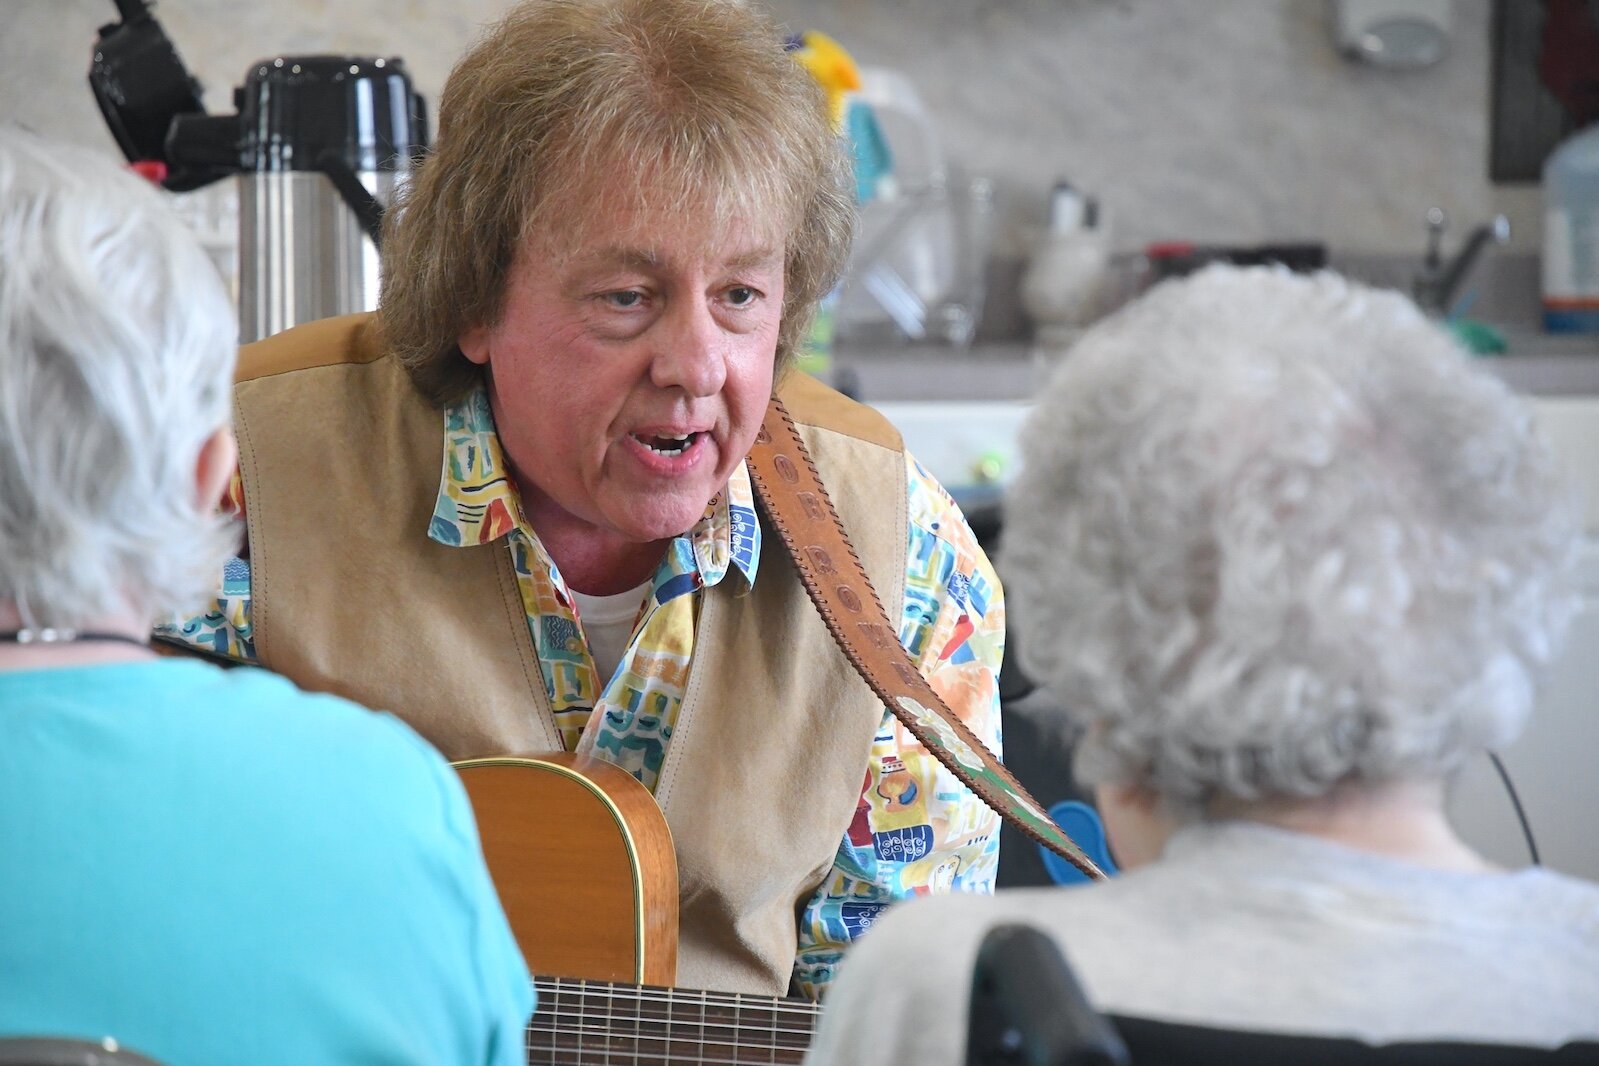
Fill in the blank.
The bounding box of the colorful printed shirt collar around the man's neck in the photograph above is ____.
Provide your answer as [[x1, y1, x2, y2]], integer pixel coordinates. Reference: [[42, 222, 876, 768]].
[[427, 385, 761, 598]]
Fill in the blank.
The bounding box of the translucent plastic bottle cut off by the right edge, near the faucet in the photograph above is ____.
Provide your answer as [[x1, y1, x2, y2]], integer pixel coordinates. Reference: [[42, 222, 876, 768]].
[[1543, 123, 1599, 332]]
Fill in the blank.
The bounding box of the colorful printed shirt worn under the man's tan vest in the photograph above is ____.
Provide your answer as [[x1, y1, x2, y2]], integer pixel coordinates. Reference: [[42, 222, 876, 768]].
[[165, 383, 1004, 999]]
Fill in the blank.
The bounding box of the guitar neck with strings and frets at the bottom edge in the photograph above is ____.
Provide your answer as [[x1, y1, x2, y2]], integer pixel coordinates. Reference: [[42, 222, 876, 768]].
[[528, 977, 822, 1066]]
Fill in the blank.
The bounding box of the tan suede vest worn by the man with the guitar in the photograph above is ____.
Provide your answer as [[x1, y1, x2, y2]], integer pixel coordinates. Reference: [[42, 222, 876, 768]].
[[235, 315, 908, 996]]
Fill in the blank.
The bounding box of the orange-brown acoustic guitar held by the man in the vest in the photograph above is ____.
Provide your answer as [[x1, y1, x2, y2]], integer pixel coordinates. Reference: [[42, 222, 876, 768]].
[[456, 753, 820, 1066]]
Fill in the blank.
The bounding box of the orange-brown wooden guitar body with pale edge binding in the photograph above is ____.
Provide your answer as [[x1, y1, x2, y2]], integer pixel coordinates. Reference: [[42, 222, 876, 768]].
[[454, 751, 678, 984]]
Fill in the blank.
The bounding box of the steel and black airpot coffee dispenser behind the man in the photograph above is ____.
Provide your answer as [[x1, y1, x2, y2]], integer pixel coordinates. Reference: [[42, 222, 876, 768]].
[[90, 0, 427, 340]]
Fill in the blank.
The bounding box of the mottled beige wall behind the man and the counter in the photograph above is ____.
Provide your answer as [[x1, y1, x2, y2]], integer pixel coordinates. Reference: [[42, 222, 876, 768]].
[[0, 0, 1538, 256]]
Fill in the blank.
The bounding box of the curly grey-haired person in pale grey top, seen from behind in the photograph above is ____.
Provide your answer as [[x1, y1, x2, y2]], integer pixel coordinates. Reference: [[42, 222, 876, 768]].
[[811, 267, 1599, 1063]]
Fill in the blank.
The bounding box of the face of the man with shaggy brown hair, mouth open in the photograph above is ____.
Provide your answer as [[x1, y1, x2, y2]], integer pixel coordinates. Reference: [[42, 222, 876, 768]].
[[461, 201, 784, 558]]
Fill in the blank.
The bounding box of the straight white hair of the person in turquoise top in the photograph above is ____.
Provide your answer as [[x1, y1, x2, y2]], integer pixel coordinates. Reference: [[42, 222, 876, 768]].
[[0, 126, 238, 628]]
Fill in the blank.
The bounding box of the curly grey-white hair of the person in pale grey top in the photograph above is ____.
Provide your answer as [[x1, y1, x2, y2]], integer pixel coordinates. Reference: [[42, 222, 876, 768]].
[[999, 267, 1580, 810]]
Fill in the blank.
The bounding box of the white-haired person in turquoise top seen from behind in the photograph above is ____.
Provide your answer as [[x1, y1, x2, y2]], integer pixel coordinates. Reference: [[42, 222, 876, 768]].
[[0, 128, 531, 1064]]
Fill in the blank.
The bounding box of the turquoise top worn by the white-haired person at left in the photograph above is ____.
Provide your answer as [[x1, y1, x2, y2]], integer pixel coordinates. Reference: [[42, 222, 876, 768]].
[[0, 660, 532, 1066]]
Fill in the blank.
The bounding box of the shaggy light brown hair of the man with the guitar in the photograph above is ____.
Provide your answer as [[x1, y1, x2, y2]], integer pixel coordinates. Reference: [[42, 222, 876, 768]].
[[379, 0, 854, 403]]
